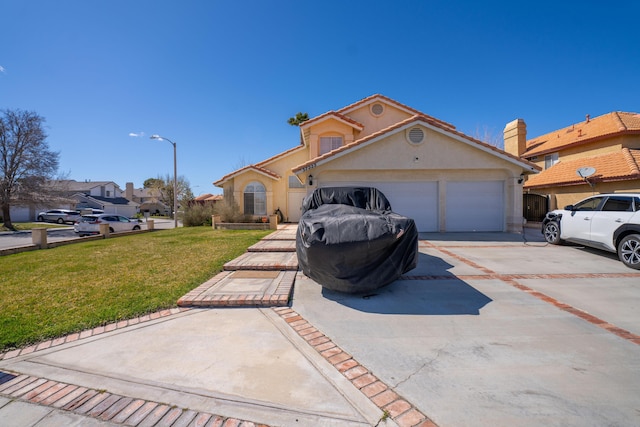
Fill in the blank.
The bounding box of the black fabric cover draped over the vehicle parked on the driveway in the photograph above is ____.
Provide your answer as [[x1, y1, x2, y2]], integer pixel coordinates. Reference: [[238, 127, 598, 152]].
[[296, 187, 418, 293]]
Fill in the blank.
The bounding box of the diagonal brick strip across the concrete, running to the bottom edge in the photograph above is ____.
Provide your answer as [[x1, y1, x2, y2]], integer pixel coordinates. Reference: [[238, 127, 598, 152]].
[[272, 307, 437, 427]]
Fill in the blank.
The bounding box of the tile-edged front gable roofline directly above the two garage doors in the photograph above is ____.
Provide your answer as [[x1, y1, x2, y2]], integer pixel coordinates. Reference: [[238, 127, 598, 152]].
[[292, 114, 540, 173]]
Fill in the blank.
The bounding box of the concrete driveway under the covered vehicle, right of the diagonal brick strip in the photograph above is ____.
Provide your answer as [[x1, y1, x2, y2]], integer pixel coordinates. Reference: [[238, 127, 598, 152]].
[[292, 229, 640, 427]]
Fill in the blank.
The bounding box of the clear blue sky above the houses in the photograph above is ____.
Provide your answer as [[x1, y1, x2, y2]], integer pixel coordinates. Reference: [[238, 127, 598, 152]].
[[0, 0, 640, 195]]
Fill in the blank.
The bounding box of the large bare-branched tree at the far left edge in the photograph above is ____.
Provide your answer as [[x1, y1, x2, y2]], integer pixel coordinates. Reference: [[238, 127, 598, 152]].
[[0, 110, 60, 230]]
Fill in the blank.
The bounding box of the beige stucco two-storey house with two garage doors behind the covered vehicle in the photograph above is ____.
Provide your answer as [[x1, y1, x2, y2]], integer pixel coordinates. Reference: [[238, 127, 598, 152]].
[[214, 95, 539, 232]]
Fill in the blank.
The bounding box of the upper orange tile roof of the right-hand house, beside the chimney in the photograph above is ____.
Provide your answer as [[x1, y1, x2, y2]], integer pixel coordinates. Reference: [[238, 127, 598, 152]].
[[522, 111, 640, 157]]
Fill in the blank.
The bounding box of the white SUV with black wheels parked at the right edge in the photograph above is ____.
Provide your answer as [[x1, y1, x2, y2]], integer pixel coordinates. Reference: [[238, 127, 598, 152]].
[[542, 193, 640, 270]]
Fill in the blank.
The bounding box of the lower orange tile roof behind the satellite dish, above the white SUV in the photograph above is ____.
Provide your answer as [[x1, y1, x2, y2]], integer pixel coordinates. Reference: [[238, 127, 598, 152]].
[[524, 148, 640, 189]]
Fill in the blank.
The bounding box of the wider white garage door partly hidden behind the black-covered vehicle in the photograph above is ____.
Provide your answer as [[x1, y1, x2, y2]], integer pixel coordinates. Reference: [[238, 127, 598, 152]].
[[321, 182, 438, 232]]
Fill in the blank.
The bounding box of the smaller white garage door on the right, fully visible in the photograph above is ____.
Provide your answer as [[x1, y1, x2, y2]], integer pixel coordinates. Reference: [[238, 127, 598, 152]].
[[445, 181, 504, 231]]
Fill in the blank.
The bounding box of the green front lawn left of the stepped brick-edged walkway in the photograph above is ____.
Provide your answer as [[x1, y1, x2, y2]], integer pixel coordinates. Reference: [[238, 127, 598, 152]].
[[0, 227, 270, 351]]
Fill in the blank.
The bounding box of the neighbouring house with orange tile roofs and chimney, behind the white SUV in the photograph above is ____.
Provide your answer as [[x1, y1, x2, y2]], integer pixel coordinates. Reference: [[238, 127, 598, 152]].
[[505, 112, 640, 216]]
